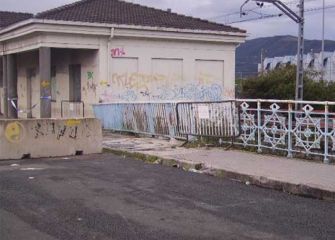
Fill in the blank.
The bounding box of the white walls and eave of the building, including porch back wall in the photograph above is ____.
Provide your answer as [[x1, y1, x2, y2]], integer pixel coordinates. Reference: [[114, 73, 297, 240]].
[[0, 28, 242, 118]]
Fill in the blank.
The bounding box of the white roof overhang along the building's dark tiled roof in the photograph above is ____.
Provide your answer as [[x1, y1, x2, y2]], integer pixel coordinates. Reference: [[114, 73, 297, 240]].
[[0, 19, 247, 44]]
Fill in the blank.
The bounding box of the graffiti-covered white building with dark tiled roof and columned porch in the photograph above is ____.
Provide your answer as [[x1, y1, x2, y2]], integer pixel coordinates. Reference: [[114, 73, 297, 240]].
[[0, 0, 246, 118]]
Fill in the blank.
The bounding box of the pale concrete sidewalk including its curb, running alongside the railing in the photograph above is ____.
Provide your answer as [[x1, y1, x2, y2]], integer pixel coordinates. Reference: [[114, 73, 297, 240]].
[[104, 134, 335, 200]]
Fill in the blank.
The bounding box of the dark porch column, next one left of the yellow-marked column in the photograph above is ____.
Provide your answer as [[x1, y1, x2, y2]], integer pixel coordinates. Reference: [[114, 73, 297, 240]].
[[6, 54, 17, 119]]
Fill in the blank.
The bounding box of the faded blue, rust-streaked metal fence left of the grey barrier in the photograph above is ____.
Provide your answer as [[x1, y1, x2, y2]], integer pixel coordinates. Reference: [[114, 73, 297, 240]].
[[93, 102, 185, 139]]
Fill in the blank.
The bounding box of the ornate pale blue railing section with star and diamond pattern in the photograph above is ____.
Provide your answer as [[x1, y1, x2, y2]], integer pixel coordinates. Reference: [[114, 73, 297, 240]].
[[235, 99, 335, 163]]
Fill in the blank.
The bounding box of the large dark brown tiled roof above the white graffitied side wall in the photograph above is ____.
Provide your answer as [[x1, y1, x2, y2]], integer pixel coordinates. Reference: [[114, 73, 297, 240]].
[[35, 0, 245, 33]]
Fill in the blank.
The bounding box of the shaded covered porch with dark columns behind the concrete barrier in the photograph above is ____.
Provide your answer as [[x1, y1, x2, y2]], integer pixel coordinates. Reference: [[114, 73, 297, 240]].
[[0, 47, 99, 119]]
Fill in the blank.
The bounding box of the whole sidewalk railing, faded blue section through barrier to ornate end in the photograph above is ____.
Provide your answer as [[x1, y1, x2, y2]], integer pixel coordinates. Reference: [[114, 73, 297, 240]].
[[94, 99, 335, 163]]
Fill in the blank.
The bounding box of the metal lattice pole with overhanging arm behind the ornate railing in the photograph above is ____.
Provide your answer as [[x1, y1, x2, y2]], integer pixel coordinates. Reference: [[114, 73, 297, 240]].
[[240, 0, 305, 104]]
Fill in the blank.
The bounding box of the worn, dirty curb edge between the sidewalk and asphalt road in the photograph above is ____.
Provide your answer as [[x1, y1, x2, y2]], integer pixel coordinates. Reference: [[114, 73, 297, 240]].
[[103, 147, 335, 201]]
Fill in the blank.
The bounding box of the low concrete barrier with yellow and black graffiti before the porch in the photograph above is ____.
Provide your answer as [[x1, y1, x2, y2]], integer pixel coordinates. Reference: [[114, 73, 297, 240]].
[[0, 118, 102, 159]]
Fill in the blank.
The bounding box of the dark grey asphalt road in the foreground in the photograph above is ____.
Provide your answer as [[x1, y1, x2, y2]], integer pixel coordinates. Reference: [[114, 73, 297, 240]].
[[0, 154, 335, 240]]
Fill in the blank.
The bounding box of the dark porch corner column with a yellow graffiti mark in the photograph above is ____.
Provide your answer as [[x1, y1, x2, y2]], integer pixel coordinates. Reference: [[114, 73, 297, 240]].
[[39, 47, 51, 118]]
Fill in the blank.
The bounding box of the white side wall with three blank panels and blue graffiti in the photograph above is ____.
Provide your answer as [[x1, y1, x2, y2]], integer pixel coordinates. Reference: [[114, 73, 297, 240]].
[[99, 39, 235, 102]]
